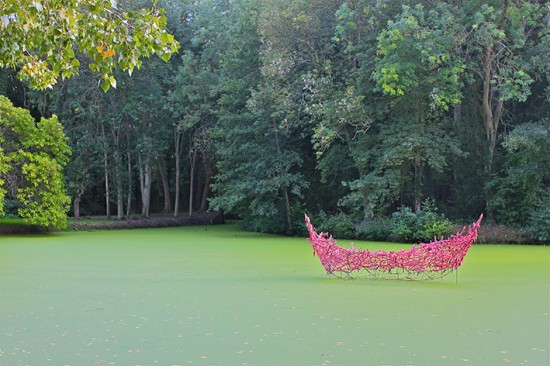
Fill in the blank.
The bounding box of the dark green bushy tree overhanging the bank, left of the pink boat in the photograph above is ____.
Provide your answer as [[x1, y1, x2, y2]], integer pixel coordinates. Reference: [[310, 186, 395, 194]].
[[210, 108, 307, 232]]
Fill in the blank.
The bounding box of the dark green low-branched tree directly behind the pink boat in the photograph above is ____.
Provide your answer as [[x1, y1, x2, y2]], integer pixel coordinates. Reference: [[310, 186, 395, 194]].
[[347, 114, 464, 213]]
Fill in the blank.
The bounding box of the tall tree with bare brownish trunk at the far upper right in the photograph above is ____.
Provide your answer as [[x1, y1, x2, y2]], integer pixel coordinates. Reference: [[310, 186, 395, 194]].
[[464, 0, 549, 173]]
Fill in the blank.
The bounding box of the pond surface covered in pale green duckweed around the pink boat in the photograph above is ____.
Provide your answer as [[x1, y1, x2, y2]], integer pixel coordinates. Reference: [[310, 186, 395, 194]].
[[0, 225, 550, 366]]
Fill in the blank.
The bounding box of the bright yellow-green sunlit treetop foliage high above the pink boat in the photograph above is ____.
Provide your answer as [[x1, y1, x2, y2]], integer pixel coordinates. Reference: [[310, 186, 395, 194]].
[[373, 3, 465, 110]]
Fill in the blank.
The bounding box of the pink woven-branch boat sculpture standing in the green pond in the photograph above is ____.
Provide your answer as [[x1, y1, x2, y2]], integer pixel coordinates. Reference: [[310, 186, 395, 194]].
[[305, 215, 483, 280]]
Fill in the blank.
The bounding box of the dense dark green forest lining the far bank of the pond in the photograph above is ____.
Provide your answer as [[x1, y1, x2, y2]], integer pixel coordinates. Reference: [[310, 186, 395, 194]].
[[0, 0, 550, 241]]
